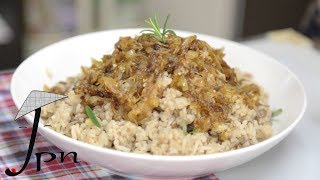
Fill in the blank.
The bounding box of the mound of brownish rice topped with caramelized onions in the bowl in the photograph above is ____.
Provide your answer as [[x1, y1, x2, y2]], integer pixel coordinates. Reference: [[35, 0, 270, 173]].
[[41, 35, 272, 155]]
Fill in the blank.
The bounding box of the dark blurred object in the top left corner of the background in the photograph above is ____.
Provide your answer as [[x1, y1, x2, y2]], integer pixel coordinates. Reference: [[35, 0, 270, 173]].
[[0, 0, 23, 70]]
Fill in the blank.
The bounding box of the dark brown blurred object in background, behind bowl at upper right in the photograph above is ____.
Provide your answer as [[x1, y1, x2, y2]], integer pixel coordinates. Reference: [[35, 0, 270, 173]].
[[243, 0, 311, 37]]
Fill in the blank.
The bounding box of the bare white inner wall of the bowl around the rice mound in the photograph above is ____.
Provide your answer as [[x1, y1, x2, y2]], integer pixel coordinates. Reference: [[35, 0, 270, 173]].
[[11, 29, 306, 139]]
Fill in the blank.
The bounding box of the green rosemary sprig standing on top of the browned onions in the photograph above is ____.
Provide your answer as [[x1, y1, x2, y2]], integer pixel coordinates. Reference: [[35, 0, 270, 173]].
[[140, 15, 176, 43]]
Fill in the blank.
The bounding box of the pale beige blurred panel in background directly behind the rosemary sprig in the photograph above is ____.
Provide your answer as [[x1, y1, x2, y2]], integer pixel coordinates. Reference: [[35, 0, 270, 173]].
[[99, 0, 245, 39]]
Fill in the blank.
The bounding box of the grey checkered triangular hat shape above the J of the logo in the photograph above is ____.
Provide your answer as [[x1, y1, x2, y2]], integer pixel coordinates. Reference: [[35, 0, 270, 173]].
[[14, 90, 67, 120]]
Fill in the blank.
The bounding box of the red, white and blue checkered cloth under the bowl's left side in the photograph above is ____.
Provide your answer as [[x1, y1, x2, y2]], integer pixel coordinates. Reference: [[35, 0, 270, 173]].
[[0, 73, 218, 180]]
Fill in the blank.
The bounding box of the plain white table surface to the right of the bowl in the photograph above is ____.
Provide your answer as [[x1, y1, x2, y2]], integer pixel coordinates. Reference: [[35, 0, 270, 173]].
[[217, 38, 320, 180]]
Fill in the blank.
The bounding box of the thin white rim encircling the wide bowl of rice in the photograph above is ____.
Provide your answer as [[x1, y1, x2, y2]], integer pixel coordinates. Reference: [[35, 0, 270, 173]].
[[10, 28, 307, 162]]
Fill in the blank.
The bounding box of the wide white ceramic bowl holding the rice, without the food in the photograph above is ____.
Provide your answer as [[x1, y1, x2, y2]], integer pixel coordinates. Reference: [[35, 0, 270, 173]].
[[11, 29, 306, 177]]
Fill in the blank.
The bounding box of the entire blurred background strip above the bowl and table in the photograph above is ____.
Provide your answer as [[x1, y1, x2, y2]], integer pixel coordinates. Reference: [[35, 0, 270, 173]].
[[0, 0, 320, 70]]
